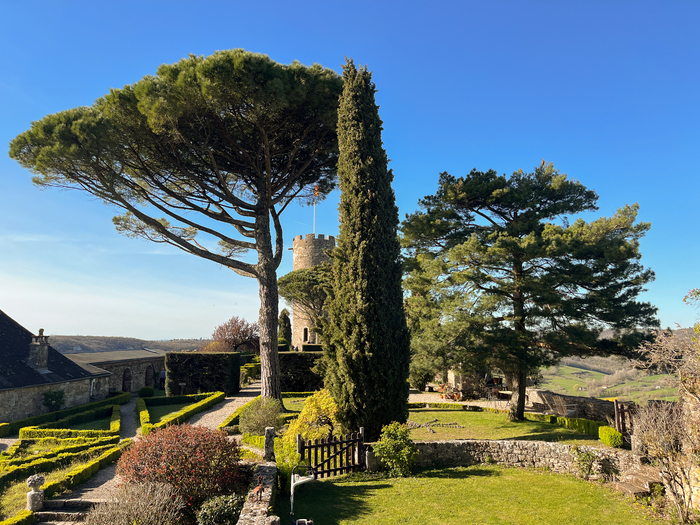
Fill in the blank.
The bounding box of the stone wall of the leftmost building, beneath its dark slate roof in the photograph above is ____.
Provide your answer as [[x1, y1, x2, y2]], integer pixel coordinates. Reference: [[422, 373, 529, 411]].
[[0, 377, 109, 423]]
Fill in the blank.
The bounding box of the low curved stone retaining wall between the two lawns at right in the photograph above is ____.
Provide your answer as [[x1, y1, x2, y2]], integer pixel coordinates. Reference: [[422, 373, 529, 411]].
[[368, 439, 639, 476]]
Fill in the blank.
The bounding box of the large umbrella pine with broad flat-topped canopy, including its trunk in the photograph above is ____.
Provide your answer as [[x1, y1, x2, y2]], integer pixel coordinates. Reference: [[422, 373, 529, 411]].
[[10, 49, 342, 397]]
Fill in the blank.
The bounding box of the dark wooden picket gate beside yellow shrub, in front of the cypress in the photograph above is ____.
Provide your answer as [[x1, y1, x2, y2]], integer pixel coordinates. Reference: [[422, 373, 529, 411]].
[[297, 428, 365, 478]]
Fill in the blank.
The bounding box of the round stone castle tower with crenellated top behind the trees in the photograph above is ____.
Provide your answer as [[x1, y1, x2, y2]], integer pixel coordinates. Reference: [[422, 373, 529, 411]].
[[292, 233, 335, 350]]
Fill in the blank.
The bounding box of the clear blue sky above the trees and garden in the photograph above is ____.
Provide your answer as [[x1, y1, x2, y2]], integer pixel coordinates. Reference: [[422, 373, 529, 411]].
[[0, 0, 700, 339]]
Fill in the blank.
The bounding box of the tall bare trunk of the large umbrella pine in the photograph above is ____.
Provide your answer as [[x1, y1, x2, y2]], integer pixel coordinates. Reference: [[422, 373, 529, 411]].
[[255, 211, 282, 400]]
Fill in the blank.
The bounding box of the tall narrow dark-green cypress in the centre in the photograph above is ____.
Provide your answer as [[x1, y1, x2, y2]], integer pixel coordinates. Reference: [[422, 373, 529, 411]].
[[322, 60, 409, 440]]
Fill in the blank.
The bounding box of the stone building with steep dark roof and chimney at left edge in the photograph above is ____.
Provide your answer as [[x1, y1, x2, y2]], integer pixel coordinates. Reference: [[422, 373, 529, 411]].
[[0, 310, 110, 423]]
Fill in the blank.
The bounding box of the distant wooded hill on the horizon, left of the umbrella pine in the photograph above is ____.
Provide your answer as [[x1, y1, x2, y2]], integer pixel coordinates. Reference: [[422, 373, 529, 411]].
[[49, 335, 211, 354]]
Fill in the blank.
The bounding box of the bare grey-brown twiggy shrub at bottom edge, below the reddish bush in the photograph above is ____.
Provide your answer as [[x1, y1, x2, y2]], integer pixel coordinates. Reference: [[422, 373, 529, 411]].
[[84, 483, 185, 525]]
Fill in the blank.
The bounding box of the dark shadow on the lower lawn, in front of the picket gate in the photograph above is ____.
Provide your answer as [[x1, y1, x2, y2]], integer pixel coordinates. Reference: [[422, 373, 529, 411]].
[[274, 480, 391, 525]]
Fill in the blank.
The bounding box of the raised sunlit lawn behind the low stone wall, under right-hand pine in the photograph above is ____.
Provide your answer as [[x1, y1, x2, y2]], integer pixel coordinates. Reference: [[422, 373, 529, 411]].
[[408, 408, 605, 446]]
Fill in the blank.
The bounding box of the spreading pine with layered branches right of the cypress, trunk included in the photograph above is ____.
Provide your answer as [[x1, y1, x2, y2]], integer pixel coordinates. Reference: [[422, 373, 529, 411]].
[[402, 161, 658, 419]]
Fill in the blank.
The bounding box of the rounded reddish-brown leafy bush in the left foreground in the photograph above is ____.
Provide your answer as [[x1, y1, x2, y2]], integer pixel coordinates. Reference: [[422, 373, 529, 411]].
[[117, 425, 248, 509]]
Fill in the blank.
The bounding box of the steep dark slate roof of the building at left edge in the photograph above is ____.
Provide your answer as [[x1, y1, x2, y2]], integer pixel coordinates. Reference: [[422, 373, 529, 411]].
[[0, 310, 102, 390]]
